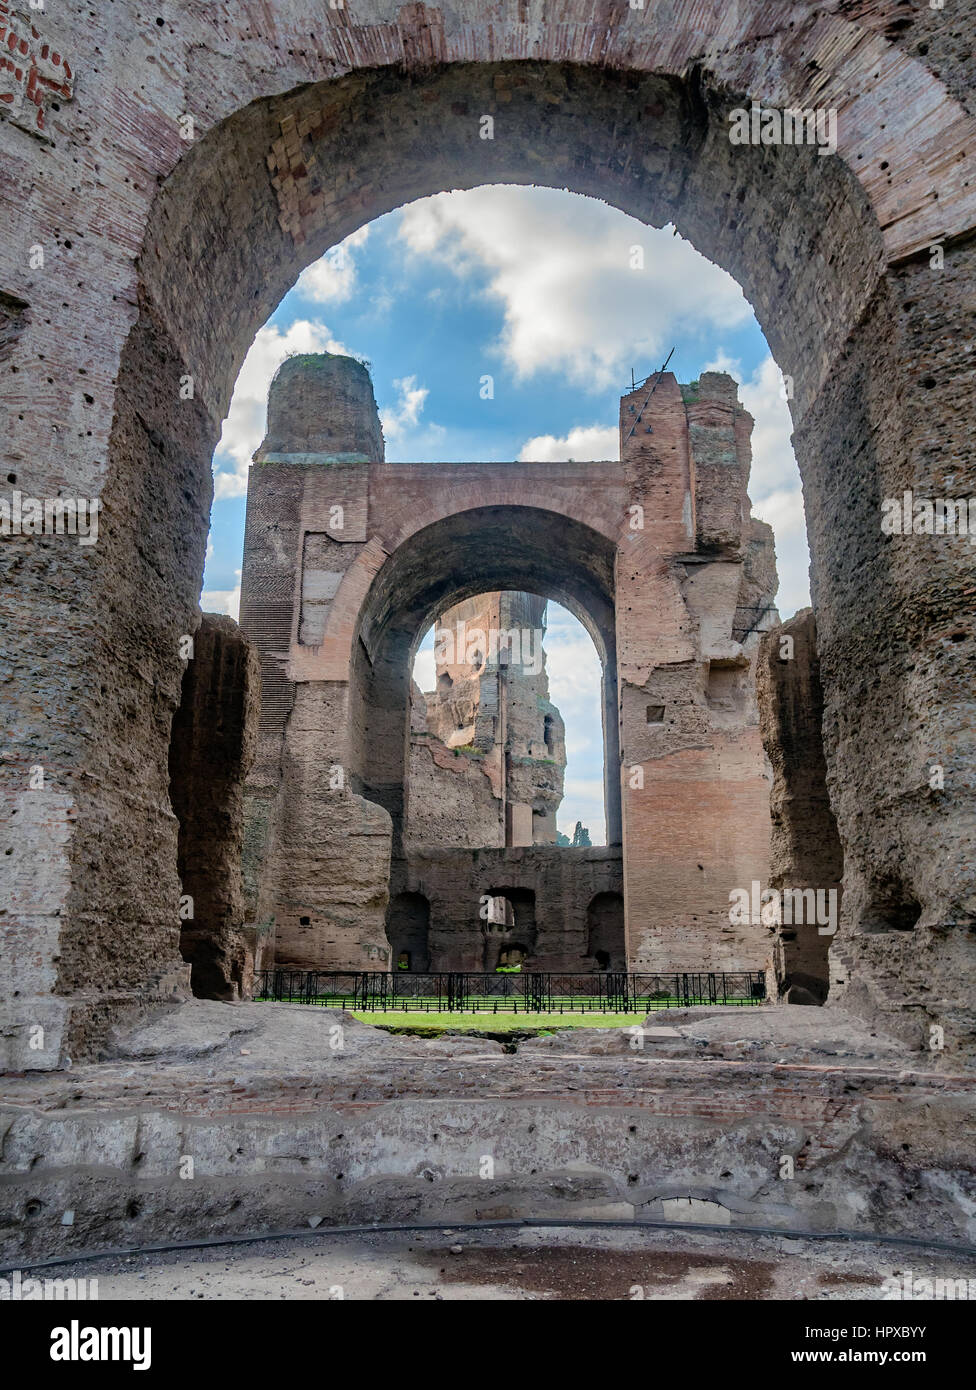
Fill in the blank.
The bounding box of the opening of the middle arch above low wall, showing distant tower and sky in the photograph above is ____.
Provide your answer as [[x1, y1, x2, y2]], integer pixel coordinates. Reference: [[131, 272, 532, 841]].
[[406, 592, 606, 849]]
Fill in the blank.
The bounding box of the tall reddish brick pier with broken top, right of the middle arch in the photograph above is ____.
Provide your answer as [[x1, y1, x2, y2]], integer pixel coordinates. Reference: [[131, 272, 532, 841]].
[[616, 373, 777, 970]]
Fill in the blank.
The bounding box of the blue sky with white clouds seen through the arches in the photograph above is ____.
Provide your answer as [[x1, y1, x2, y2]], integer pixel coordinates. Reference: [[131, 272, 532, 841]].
[[202, 186, 809, 844]]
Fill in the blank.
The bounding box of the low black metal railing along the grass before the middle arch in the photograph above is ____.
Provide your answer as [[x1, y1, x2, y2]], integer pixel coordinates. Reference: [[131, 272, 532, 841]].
[[254, 970, 766, 1015]]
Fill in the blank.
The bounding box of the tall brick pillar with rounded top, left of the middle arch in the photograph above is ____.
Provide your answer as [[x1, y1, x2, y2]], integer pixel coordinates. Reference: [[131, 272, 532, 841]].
[[241, 353, 392, 969]]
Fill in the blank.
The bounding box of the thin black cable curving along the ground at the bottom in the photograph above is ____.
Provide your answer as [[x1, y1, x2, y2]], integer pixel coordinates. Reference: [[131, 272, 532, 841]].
[[0, 1216, 976, 1275]]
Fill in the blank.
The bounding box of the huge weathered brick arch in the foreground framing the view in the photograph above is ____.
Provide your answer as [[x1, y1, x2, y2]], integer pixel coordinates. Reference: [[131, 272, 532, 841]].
[[0, 0, 976, 1055]]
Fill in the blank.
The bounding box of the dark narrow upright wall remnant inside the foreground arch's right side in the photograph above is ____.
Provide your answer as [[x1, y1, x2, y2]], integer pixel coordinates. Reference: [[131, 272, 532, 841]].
[[758, 609, 844, 1004]]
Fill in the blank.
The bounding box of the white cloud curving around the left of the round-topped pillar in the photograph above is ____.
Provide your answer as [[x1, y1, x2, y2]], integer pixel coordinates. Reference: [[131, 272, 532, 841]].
[[214, 318, 349, 498]]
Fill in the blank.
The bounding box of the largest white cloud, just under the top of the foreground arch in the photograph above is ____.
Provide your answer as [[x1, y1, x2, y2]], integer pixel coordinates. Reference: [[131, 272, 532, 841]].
[[399, 186, 751, 391]]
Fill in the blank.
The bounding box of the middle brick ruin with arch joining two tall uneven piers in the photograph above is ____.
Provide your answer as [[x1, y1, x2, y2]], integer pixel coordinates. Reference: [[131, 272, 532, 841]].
[[234, 354, 776, 970]]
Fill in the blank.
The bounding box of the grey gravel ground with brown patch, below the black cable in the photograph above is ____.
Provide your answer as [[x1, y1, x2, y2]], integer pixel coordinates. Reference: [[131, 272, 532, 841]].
[[17, 1227, 976, 1301]]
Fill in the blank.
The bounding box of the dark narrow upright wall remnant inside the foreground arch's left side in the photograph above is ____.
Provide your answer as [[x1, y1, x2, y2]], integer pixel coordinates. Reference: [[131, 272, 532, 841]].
[[170, 613, 261, 999]]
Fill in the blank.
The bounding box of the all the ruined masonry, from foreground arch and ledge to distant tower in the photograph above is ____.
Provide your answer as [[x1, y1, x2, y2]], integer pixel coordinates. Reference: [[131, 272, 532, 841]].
[[0, 0, 976, 1289]]
